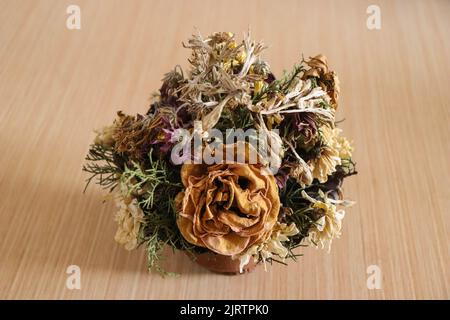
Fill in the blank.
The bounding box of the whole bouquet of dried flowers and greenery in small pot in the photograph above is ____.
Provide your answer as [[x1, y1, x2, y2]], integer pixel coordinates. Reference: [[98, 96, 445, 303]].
[[83, 32, 356, 274]]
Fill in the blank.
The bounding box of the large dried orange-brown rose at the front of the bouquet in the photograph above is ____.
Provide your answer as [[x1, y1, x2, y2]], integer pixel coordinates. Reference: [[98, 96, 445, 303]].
[[175, 144, 280, 256]]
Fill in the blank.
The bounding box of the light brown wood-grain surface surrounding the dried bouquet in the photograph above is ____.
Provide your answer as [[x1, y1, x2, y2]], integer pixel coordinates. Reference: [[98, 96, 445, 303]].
[[0, 0, 450, 299]]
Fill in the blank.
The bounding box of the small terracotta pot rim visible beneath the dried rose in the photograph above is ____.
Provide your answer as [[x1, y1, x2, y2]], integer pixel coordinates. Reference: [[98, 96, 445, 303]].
[[194, 252, 257, 275]]
